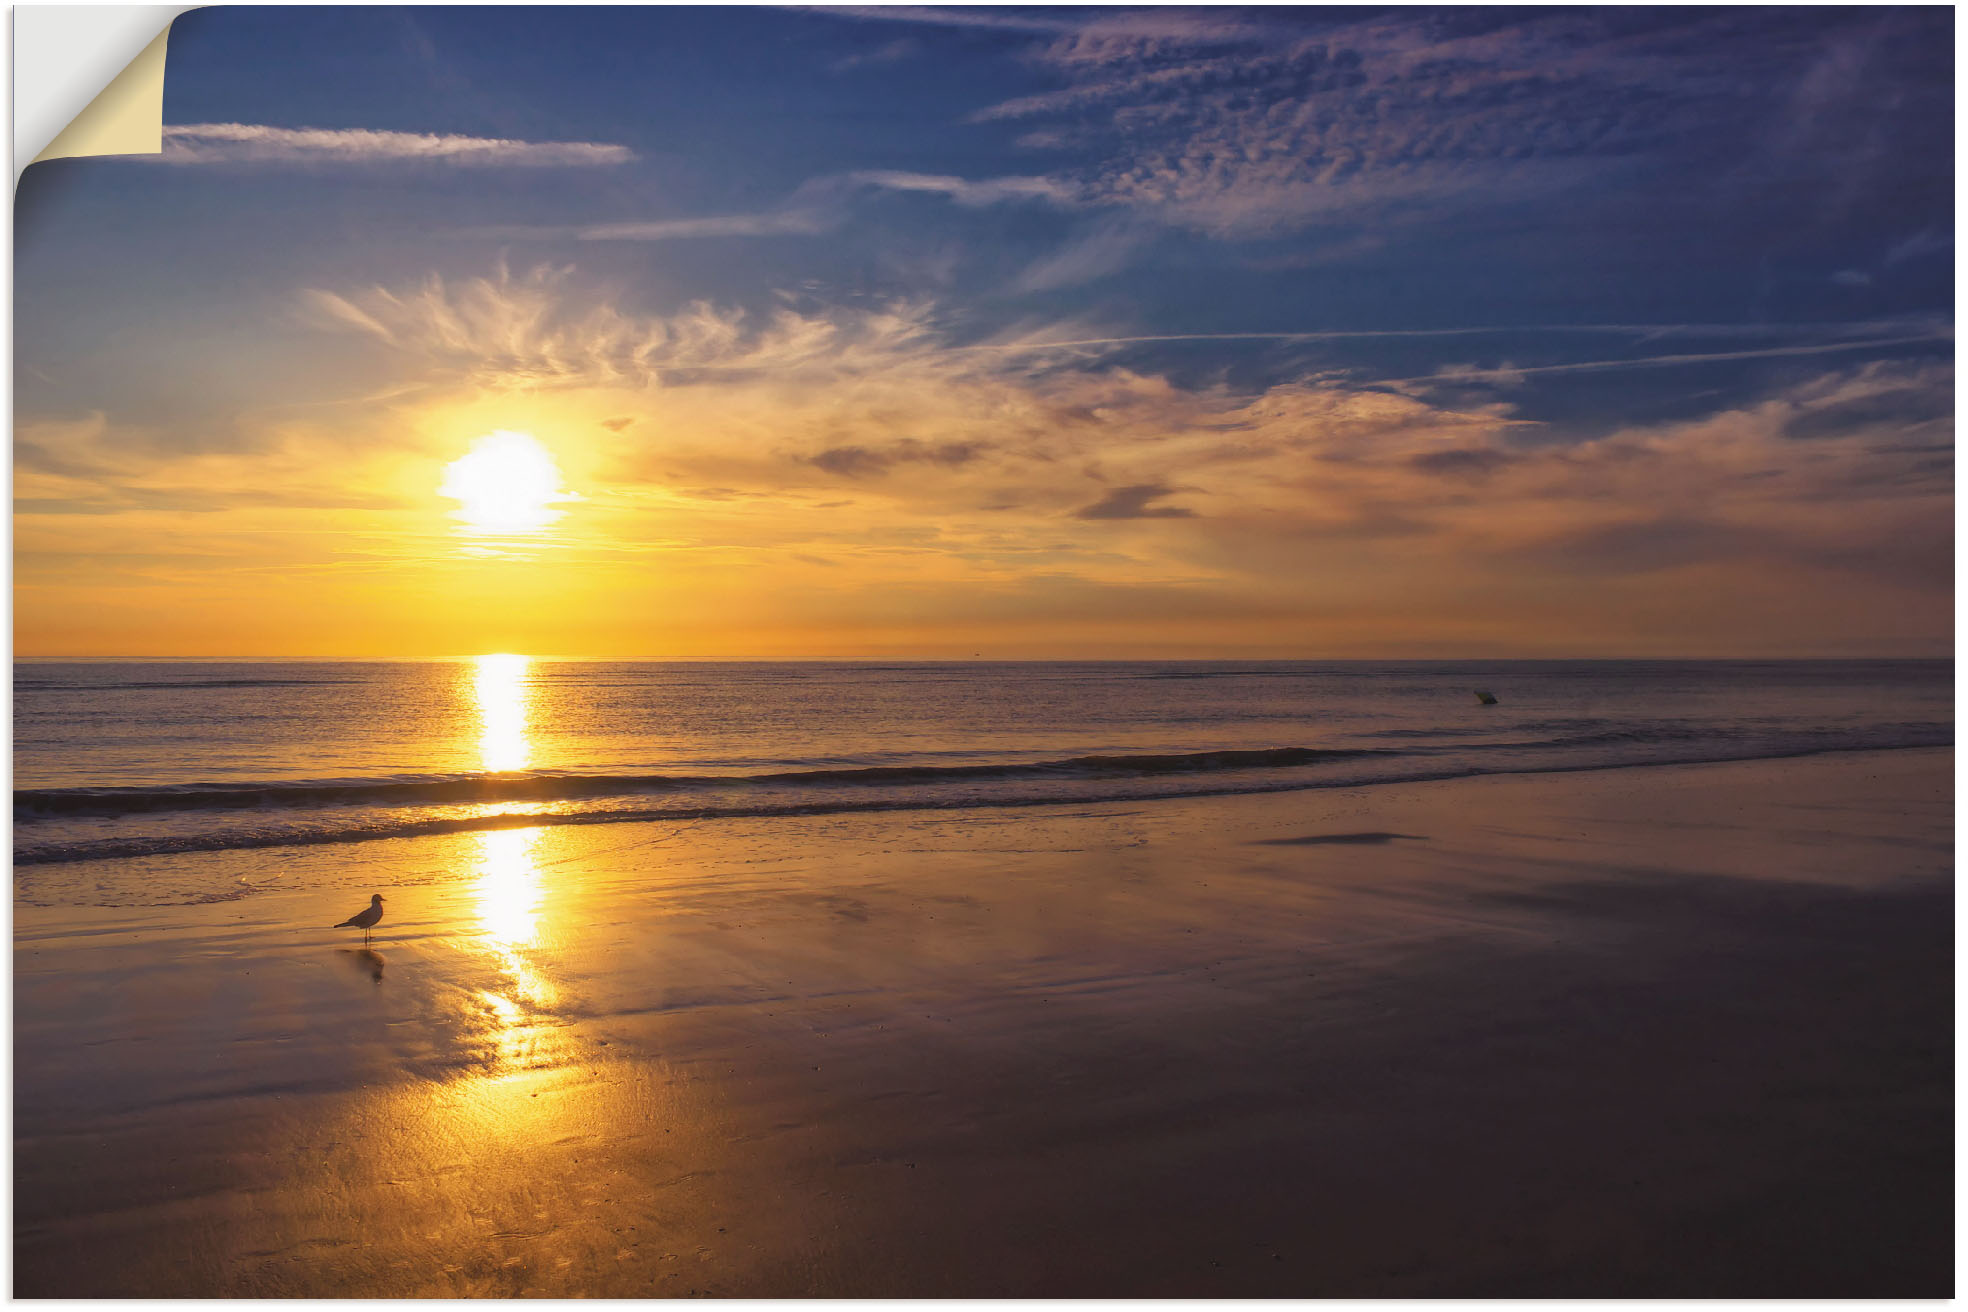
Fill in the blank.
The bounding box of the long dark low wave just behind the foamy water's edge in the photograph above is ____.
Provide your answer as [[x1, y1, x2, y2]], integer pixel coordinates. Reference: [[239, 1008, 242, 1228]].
[[14, 747, 1393, 822]]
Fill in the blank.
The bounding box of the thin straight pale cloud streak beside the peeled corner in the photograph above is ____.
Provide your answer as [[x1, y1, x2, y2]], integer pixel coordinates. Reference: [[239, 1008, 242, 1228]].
[[146, 124, 636, 167]]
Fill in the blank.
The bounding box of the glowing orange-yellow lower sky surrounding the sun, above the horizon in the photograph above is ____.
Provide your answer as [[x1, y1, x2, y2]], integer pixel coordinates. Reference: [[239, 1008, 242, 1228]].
[[16, 273, 1952, 659]]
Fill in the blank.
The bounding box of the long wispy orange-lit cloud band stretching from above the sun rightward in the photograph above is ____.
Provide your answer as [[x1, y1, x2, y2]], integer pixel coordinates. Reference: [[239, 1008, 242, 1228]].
[[295, 268, 1952, 541]]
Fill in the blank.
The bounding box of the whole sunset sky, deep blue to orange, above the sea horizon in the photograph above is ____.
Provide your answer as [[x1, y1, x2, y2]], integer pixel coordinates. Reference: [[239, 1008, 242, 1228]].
[[14, 6, 1954, 659]]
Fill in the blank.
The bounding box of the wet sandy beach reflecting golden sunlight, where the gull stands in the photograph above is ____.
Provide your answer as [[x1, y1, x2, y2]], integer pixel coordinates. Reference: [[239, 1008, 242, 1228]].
[[14, 749, 1952, 1298]]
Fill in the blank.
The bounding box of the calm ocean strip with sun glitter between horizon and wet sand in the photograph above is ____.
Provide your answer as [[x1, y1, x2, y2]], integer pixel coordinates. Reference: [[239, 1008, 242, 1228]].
[[14, 655, 1954, 905]]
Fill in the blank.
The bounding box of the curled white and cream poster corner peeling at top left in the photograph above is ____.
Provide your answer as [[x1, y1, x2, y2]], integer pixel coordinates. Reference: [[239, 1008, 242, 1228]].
[[14, 4, 195, 185]]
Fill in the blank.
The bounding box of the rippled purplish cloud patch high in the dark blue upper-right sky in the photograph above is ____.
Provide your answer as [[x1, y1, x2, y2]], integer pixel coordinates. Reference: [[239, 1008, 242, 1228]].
[[972, 18, 1668, 236]]
